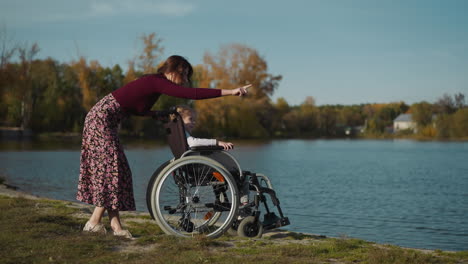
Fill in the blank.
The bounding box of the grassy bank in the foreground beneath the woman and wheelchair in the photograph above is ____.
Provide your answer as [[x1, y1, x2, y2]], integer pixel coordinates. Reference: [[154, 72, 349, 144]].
[[0, 196, 468, 264]]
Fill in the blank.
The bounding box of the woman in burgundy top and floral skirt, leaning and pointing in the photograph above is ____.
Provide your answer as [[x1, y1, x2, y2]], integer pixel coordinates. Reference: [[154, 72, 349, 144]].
[[77, 56, 250, 238]]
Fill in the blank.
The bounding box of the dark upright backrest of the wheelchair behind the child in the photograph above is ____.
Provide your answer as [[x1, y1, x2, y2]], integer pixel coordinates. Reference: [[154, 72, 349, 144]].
[[164, 114, 189, 159]]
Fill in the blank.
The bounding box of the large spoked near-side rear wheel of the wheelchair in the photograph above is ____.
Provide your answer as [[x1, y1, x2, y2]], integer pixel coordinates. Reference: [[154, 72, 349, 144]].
[[150, 156, 239, 238]]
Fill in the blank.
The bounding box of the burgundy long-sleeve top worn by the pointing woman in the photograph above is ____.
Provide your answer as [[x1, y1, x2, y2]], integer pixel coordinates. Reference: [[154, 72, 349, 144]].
[[112, 74, 221, 115]]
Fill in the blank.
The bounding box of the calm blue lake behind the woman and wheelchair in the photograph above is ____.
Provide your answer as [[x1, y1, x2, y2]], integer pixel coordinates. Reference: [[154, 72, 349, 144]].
[[0, 140, 468, 250]]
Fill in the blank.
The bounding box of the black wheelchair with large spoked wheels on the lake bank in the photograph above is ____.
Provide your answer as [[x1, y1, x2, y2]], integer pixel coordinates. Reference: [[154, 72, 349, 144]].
[[146, 110, 290, 238]]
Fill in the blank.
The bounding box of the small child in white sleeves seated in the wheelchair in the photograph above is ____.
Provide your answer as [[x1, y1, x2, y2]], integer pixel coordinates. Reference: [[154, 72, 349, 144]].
[[176, 105, 249, 207]]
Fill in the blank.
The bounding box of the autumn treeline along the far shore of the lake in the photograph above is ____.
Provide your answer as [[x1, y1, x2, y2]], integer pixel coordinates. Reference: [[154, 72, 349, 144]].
[[0, 33, 468, 138]]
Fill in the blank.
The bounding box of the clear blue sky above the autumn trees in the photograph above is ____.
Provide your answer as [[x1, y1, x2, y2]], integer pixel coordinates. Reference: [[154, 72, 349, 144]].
[[0, 0, 468, 105]]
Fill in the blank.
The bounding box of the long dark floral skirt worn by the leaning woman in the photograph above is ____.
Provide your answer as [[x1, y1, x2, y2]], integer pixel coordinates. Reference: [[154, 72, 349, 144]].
[[76, 94, 135, 211]]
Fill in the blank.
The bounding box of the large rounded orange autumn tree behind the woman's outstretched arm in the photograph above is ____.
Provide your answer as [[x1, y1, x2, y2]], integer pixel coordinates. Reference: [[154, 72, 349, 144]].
[[195, 44, 281, 137]]
